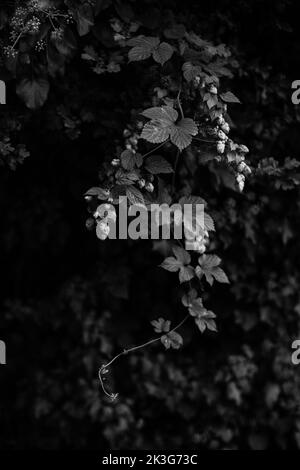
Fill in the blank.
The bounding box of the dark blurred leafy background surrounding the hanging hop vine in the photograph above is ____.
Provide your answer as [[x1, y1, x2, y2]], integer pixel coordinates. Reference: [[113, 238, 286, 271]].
[[0, 0, 300, 450]]
